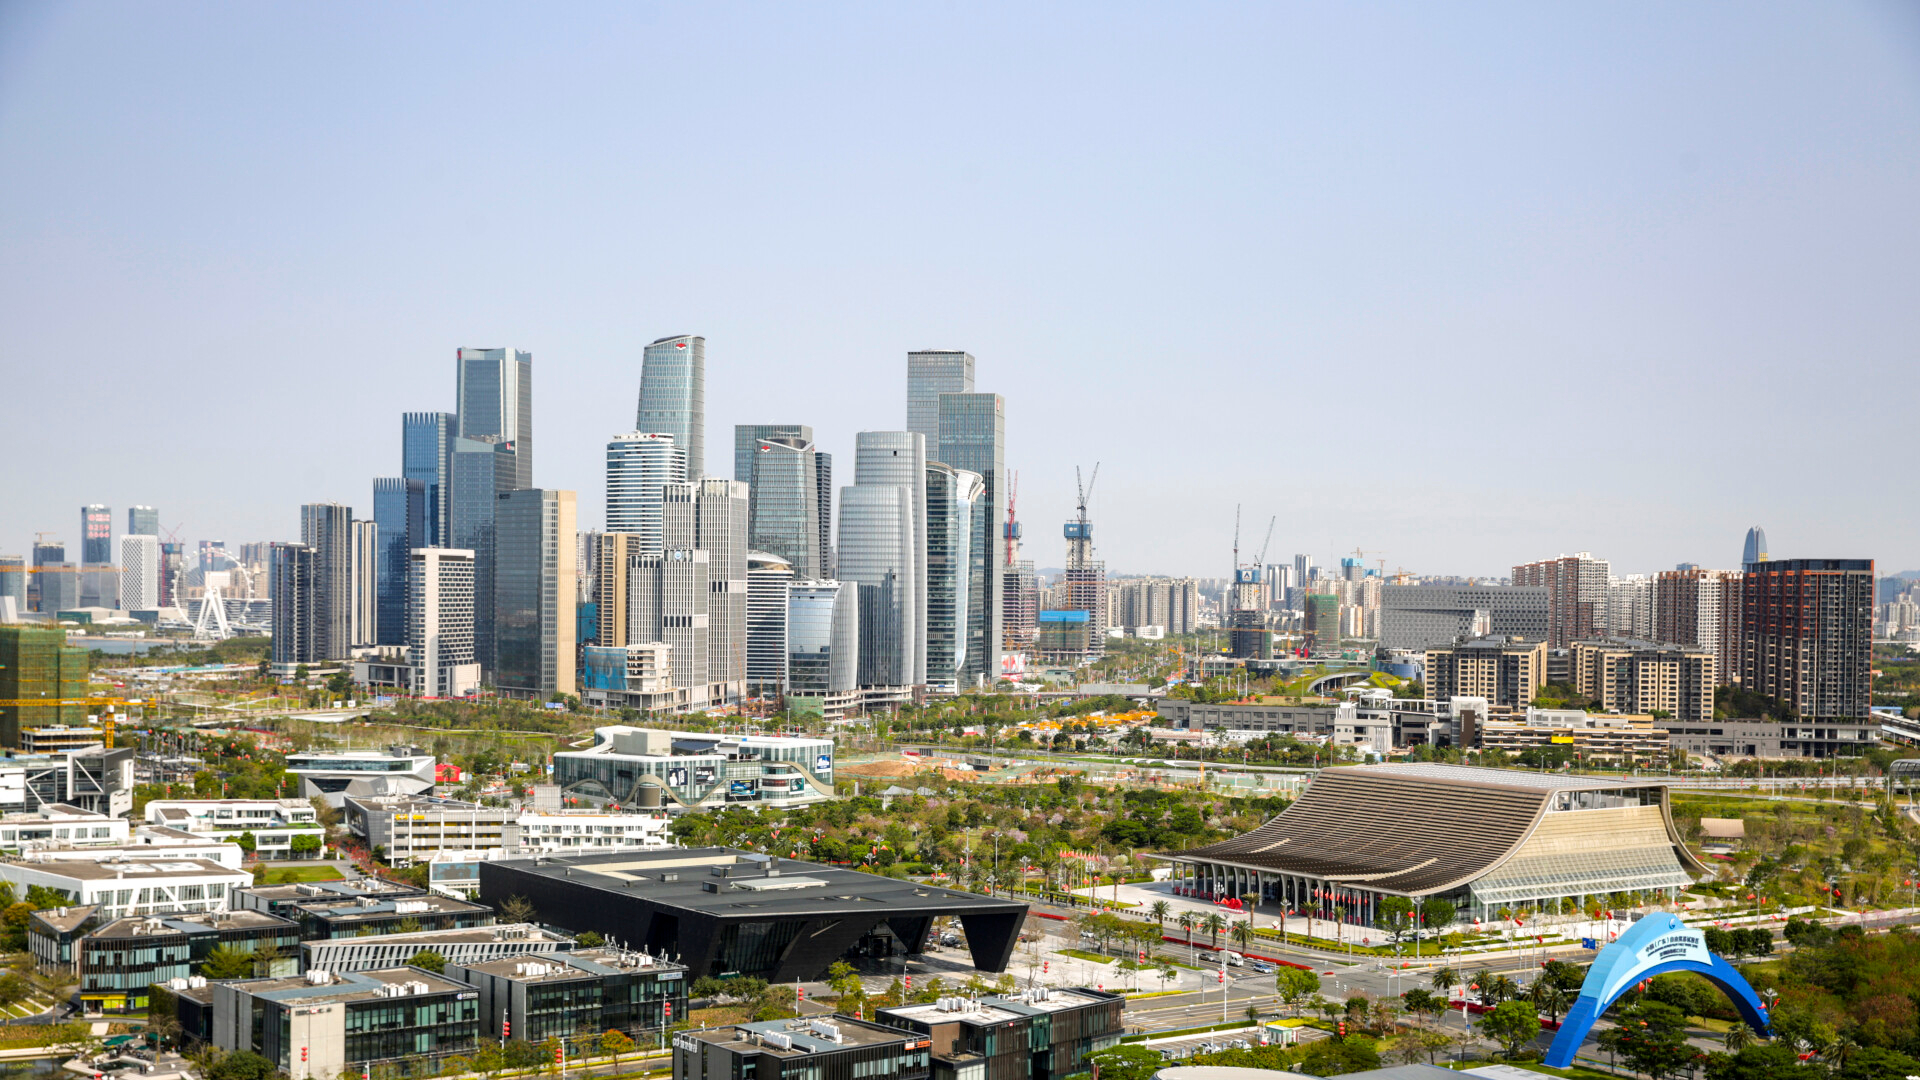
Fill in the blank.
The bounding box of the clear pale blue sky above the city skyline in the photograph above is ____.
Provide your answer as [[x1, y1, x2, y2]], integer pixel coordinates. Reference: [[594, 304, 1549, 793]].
[[0, 2, 1920, 575]]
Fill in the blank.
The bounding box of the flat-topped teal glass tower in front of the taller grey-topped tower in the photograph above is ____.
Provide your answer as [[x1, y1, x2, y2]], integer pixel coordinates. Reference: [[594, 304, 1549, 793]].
[[929, 393, 1006, 686]]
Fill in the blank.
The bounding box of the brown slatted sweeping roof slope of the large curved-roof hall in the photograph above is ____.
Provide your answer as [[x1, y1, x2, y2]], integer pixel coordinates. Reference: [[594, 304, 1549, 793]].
[[1173, 765, 1559, 896]]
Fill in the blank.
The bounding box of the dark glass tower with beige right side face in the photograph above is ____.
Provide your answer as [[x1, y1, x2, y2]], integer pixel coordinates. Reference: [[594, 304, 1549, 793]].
[[493, 488, 580, 701]]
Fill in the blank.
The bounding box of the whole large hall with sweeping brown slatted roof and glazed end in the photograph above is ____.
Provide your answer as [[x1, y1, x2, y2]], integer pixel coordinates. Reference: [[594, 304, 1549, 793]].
[[1164, 763, 1709, 924]]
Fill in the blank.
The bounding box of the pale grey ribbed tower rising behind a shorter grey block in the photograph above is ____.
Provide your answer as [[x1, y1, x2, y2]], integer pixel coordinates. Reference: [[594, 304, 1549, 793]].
[[660, 477, 747, 705]]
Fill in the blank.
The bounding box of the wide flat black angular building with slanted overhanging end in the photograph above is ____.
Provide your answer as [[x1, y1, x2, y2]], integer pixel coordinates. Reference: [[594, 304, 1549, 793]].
[[480, 847, 1027, 982]]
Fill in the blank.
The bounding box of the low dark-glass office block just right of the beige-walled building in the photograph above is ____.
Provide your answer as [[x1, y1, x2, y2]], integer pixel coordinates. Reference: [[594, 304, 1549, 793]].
[[447, 949, 687, 1042]]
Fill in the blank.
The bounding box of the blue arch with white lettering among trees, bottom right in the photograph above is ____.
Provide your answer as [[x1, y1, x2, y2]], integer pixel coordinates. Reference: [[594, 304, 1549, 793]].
[[1546, 915, 1768, 1068]]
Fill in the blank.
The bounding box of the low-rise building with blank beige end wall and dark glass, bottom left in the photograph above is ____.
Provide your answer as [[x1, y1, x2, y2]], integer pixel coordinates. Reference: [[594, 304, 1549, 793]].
[[206, 967, 480, 1080]]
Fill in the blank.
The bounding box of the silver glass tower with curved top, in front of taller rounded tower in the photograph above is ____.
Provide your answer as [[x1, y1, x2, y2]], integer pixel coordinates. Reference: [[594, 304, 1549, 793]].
[[839, 484, 925, 686]]
